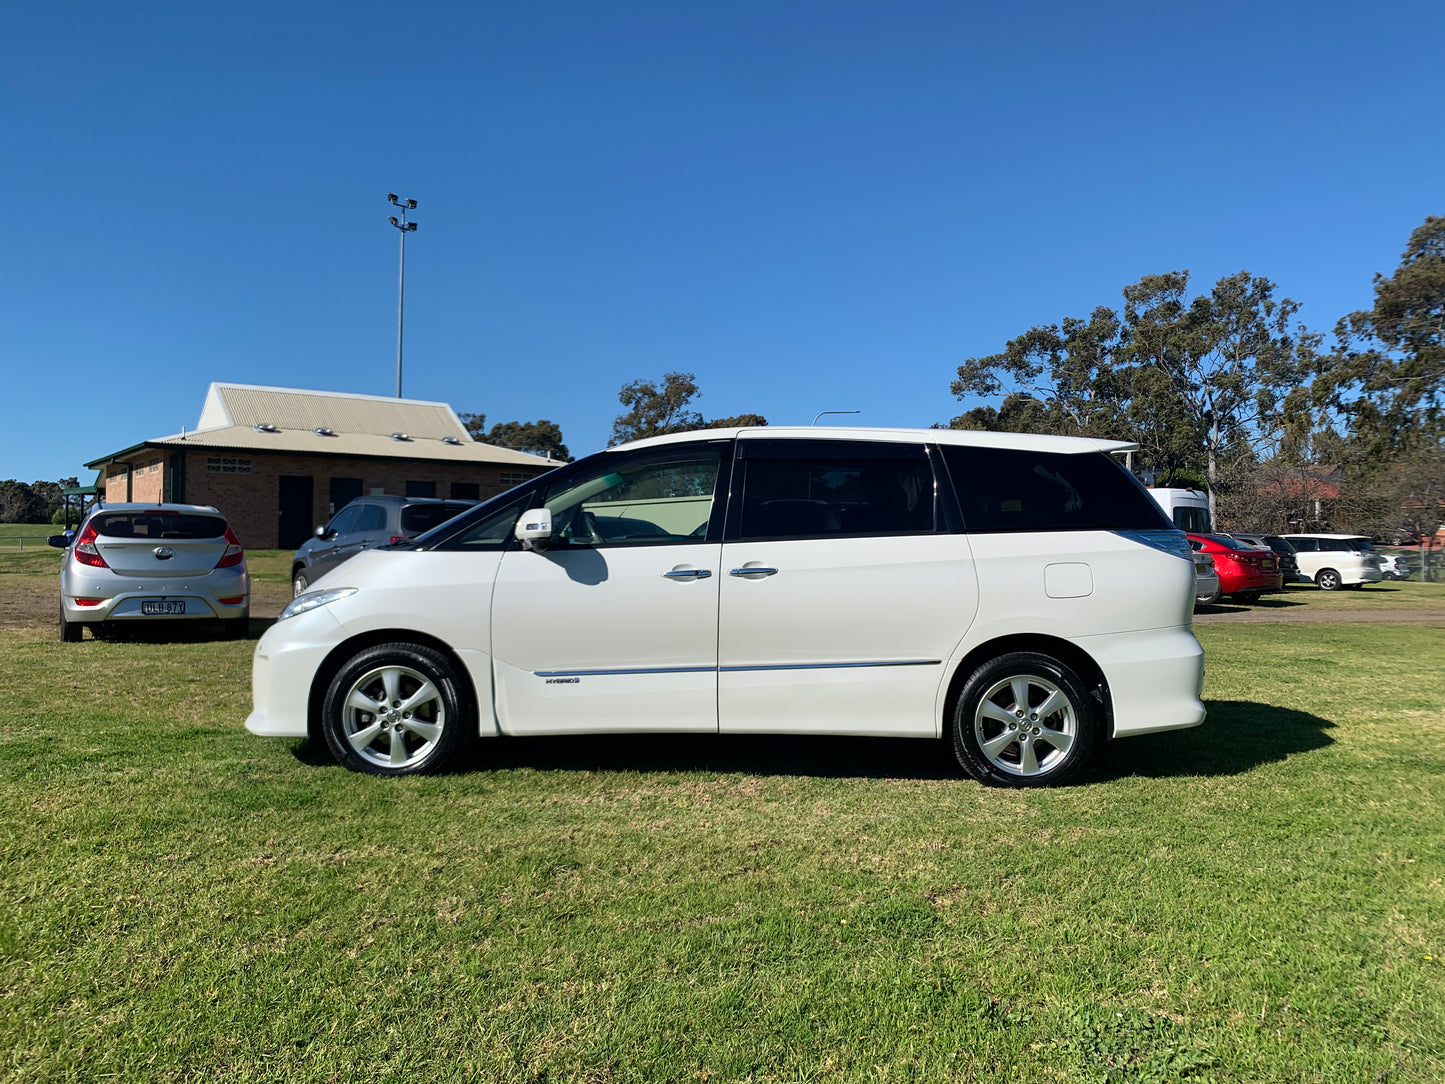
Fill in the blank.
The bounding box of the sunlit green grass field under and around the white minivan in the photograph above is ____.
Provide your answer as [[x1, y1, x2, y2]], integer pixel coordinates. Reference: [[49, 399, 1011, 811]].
[[0, 551, 1445, 1084]]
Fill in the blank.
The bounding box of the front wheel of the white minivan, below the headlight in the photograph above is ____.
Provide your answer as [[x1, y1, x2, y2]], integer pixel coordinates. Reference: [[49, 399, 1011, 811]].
[[321, 643, 475, 775]]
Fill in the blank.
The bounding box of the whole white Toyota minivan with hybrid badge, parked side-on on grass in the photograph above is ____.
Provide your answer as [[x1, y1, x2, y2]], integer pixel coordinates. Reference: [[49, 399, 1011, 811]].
[[246, 428, 1204, 786]]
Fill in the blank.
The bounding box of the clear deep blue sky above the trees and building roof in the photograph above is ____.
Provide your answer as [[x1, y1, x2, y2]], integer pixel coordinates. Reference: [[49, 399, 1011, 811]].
[[0, 0, 1445, 481]]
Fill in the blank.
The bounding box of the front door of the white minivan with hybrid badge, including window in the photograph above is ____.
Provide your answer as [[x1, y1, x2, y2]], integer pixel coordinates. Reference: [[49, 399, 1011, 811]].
[[491, 441, 728, 734]]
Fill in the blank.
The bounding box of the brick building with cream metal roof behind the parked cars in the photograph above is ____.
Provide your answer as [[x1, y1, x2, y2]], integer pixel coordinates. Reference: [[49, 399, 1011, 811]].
[[85, 383, 558, 549]]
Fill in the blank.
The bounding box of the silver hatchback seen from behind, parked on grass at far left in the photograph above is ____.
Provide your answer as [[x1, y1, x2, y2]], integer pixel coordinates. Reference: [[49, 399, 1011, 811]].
[[49, 503, 251, 643]]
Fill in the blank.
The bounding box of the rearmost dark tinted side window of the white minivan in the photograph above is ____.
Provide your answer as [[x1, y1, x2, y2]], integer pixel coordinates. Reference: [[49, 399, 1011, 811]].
[[942, 444, 1173, 533]]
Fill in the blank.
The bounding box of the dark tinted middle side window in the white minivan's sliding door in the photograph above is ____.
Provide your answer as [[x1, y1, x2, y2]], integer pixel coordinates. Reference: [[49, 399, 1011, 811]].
[[740, 458, 933, 539]]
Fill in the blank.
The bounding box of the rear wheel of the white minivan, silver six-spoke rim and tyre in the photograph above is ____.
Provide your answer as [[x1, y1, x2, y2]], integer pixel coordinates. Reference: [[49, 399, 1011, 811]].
[[952, 652, 1098, 788]]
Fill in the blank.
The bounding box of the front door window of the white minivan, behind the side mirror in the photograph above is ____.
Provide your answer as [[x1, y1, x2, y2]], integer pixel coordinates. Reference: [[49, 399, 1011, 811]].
[[543, 444, 725, 546]]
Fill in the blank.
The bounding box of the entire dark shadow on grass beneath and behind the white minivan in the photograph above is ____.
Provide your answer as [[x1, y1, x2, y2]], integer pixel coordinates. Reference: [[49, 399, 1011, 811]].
[[290, 700, 1334, 786]]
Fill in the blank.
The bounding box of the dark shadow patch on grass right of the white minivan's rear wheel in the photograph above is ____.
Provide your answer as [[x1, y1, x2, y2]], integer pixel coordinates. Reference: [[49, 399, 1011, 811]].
[[1079, 700, 1335, 783]]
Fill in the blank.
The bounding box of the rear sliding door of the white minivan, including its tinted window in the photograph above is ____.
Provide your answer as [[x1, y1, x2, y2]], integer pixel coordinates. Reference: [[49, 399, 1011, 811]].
[[718, 439, 978, 737]]
